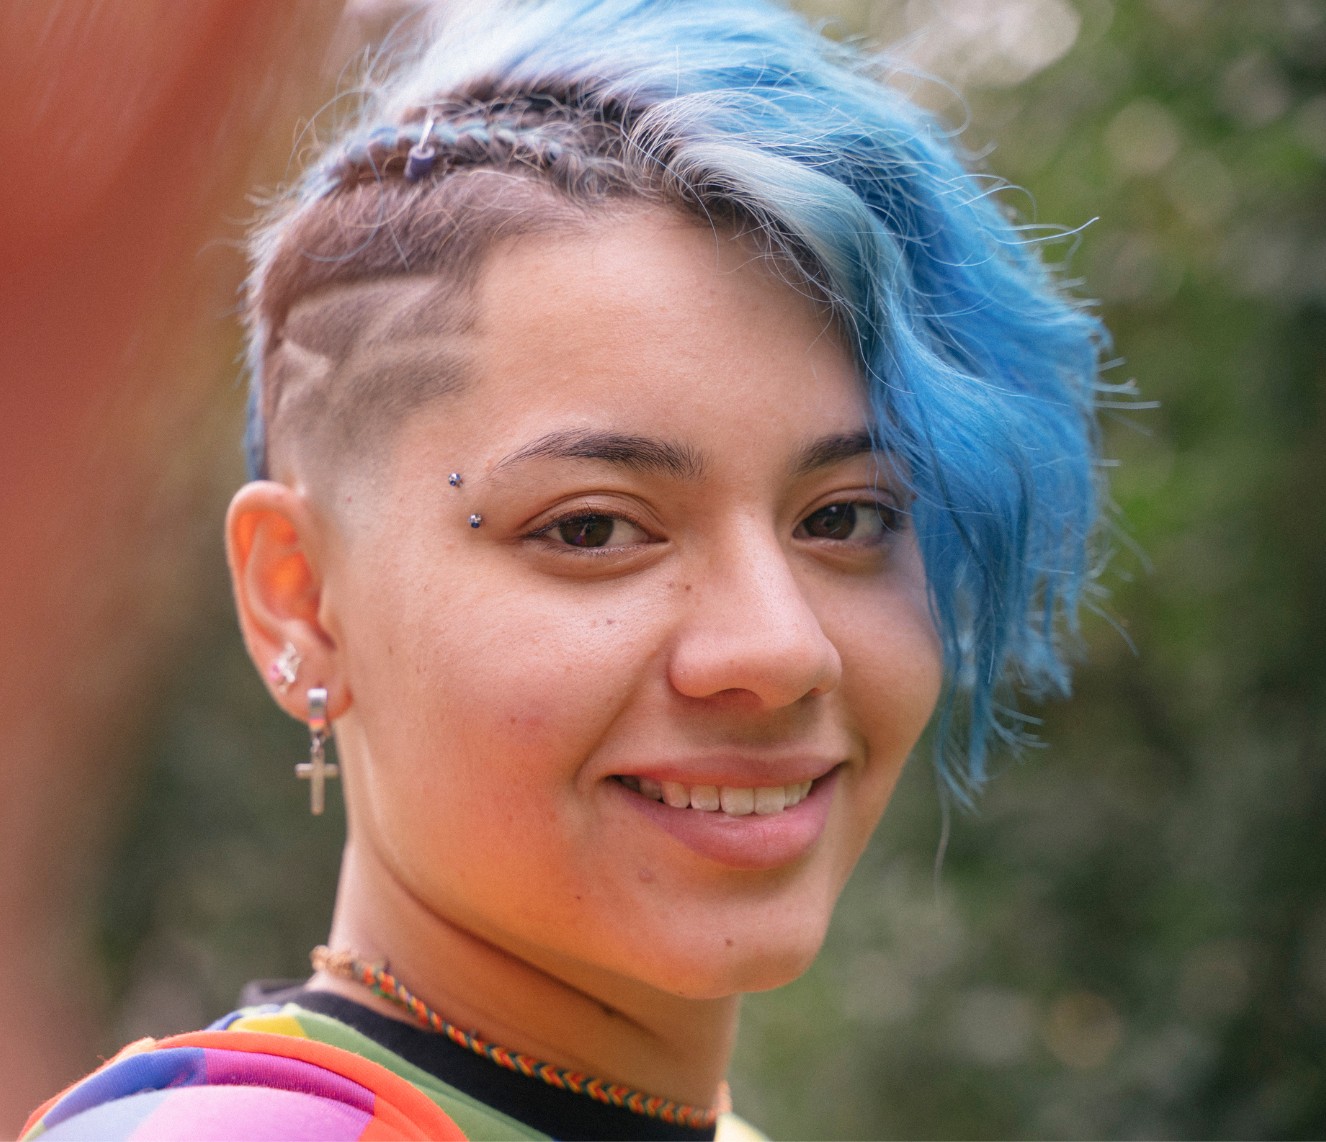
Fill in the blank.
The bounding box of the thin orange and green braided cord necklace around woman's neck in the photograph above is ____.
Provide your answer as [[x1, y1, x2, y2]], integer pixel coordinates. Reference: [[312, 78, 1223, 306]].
[[309, 946, 729, 1130]]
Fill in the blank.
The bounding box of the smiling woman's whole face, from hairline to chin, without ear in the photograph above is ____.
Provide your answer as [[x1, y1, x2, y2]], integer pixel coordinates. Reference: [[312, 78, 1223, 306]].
[[322, 210, 940, 996]]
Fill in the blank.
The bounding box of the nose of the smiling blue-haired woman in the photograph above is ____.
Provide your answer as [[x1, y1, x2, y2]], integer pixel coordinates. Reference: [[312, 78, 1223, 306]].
[[668, 525, 842, 710]]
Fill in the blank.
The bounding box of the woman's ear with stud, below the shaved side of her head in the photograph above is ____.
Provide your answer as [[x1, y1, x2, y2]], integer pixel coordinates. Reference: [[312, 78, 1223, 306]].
[[225, 480, 351, 722]]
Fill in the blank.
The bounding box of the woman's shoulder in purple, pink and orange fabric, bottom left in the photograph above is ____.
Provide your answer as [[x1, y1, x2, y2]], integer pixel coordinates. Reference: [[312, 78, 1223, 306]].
[[23, 1009, 467, 1142]]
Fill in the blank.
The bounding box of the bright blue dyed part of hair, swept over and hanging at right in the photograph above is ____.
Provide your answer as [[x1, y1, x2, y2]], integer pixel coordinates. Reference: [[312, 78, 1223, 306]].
[[249, 0, 1107, 801]]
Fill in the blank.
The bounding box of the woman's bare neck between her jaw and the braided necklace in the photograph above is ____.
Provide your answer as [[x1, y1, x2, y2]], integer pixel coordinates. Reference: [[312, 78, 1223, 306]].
[[313, 842, 739, 1106]]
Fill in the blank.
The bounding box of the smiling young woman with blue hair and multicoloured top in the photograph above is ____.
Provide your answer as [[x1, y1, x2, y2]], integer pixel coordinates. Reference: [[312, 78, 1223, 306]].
[[29, 0, 1101, 1138]]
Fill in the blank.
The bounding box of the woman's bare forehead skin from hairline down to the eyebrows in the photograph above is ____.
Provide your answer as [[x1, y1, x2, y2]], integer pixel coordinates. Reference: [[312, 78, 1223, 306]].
[[350, 211, 869, 495]]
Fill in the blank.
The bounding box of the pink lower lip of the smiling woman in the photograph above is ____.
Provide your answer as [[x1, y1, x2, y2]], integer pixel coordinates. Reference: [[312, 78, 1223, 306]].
[[607, 769, 838, 871]]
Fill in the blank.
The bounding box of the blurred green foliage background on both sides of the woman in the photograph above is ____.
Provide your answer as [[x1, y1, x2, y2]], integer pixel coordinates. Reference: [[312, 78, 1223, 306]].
[[98, 0, 1326, 1138]]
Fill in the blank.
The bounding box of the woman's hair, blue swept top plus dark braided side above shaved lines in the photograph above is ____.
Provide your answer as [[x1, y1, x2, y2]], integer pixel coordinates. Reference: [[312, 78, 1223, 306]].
[[248, 0, 1106, 800]]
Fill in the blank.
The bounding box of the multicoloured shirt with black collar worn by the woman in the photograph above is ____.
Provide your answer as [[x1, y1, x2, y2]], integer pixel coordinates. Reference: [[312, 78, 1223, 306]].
[[21, 992, 761, 1142]]
